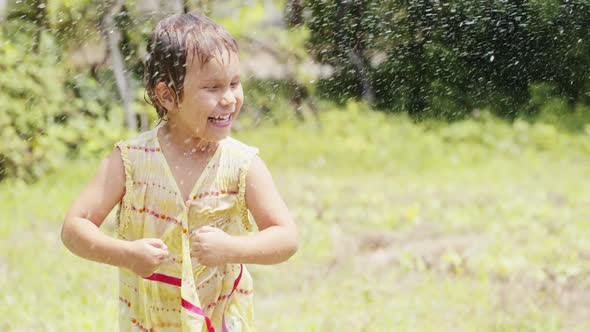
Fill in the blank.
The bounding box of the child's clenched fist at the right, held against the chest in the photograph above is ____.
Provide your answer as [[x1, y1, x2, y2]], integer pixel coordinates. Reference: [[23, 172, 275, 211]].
[[191, 226, 234, 266]]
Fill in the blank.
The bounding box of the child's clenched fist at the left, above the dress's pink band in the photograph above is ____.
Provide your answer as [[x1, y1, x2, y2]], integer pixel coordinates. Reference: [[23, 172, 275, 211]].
[[128, 239, 169, 277]]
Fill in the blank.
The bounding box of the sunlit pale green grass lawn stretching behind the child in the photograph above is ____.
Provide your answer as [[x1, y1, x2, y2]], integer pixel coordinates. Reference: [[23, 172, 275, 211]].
[[0, 104, 590, 332]]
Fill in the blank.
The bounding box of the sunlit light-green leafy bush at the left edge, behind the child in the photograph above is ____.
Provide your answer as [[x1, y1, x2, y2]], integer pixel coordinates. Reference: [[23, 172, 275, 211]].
[[0, 41, 129, 181]]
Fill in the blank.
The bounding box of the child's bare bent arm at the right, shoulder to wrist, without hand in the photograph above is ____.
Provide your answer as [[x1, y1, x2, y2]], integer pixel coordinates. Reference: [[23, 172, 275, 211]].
[[229, 157, 298, 264]]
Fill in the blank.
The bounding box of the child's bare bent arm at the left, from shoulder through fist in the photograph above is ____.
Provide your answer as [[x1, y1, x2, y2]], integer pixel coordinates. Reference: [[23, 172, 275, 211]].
[[61, 149, 168, 275]]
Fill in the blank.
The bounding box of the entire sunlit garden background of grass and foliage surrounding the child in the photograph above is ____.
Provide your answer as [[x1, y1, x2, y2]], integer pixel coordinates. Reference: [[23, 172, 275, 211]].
[[0, 0, 590, 332]]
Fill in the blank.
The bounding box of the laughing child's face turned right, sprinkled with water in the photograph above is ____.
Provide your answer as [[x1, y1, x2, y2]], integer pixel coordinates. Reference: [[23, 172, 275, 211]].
[[170, 52, 244, 142]]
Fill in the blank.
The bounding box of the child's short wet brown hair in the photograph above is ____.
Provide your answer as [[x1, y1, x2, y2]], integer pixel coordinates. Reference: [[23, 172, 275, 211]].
[[143, 13, 239, 119]]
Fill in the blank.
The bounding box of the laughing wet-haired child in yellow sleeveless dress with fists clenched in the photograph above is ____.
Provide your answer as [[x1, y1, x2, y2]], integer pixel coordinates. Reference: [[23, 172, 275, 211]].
[[62, 14, 297, 332]]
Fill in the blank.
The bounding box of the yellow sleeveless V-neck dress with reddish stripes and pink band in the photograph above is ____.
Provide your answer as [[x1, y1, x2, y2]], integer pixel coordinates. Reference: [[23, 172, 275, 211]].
[[116, 126, 258, 332]]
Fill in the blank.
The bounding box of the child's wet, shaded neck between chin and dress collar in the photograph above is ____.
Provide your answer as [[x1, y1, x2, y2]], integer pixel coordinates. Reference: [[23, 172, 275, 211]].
[[159, 122, 218, 157]]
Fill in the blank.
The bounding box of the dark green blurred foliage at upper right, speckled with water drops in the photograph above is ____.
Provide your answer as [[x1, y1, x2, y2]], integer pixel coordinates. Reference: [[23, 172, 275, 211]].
[[305, 0, 590, 119]]
